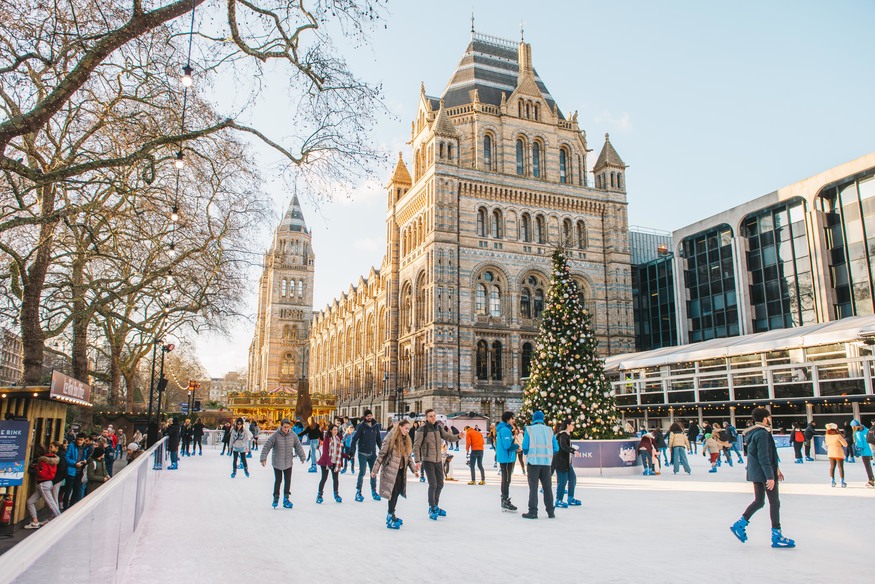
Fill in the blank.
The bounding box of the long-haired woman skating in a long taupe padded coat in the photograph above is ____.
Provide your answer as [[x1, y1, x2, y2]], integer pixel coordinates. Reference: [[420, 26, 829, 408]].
[[371, 418, 419, 529]]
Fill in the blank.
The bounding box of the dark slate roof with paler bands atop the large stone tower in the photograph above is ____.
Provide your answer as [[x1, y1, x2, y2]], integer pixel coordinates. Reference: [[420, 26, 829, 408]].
[[441, 33, 565, 119]]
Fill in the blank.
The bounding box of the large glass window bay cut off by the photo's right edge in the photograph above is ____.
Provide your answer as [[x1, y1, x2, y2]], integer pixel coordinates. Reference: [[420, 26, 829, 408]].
[[817, 171, 875, 318]]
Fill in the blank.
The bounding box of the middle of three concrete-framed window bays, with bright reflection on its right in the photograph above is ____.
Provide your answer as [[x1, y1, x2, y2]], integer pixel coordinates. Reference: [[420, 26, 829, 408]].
[[742, 198, 817, 333]]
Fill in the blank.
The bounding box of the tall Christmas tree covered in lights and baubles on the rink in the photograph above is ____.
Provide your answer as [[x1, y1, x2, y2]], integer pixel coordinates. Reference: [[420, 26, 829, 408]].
[[520, 248, 618, 438]]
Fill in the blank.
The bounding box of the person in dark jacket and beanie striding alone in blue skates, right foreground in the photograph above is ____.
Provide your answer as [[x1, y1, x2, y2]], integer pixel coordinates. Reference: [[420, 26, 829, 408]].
[[729, 408, 796, 548]]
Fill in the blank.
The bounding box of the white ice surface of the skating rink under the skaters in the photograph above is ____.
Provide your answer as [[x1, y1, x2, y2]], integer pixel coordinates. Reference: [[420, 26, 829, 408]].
[[121, 449, 875, 584]]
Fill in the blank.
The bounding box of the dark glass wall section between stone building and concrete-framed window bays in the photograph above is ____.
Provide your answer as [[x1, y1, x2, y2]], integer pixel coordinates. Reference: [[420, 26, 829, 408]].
[[632, 254, 678, 351]]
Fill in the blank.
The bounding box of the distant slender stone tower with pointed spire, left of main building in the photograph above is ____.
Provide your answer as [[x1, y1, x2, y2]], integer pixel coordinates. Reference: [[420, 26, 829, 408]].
[[247, 196, 315, 392]]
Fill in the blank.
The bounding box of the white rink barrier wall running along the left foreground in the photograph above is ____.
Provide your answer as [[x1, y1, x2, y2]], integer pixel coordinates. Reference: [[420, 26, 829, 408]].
[[0, 438, 166, 584]]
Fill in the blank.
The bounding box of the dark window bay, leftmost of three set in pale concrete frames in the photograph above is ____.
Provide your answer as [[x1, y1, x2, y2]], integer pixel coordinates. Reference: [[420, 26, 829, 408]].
[[681, 223, 739, 343]]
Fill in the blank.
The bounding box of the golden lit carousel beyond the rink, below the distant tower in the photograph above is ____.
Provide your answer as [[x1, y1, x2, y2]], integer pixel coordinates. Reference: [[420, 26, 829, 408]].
[[227, 382, 336, 429]]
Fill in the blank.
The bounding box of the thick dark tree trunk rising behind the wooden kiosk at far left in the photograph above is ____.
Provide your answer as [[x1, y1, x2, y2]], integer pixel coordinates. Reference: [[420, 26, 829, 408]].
[[21, 186, 58, 385]]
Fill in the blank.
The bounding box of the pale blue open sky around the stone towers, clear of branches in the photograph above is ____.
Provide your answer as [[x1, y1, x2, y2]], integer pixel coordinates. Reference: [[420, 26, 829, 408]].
[[193, 0, 875, 377]]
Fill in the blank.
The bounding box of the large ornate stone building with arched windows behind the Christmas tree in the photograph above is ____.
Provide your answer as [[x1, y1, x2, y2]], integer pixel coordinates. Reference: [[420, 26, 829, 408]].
[[310, 34, 634, 421]]
